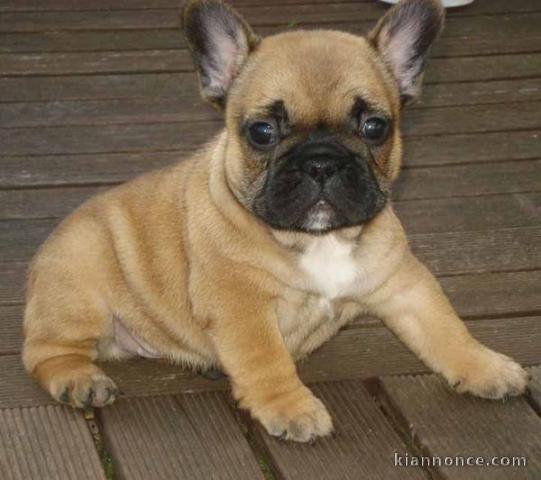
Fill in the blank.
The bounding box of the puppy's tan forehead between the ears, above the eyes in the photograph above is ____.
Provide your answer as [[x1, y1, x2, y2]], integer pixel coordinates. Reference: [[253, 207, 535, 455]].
[[229, 31, 398, 125]]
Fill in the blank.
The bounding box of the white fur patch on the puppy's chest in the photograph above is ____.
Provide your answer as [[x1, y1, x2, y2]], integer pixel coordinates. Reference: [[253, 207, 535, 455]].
[[300, 235, 359, 299]]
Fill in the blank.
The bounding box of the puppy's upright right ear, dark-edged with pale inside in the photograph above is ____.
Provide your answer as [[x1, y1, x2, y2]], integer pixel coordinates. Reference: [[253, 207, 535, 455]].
[[368, 0, 445, 102]]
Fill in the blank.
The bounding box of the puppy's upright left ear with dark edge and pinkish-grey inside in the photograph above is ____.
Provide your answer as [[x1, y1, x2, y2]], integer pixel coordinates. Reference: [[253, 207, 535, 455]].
[[181, 0, 259, 108]]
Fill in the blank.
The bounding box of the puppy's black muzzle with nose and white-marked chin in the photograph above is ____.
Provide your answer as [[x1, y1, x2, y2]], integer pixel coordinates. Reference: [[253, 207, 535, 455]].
[[253, 143, 387, 233]]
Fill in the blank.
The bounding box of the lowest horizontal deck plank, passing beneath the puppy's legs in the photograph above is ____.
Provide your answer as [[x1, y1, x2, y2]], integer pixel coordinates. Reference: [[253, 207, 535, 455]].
[[0, 316, 541, 408]]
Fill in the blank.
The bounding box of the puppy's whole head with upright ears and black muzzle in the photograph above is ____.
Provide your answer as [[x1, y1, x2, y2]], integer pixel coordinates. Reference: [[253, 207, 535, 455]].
[[182, 0, 444, 233]]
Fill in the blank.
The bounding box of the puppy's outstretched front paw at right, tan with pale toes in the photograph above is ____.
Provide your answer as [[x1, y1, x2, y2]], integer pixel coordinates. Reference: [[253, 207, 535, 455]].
[[450, 348, 529, 399]]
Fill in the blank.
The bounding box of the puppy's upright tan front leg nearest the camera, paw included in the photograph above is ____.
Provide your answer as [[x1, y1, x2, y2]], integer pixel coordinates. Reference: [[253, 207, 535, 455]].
[[210, 294, 332, 442]]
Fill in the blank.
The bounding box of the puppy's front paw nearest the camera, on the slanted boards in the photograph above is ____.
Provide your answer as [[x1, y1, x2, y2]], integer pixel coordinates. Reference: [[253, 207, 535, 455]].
[[252, 386, 333, 442]]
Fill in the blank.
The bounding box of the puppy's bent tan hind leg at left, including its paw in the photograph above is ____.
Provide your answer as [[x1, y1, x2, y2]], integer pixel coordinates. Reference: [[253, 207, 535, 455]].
[[23, 280, 118, 408]]
